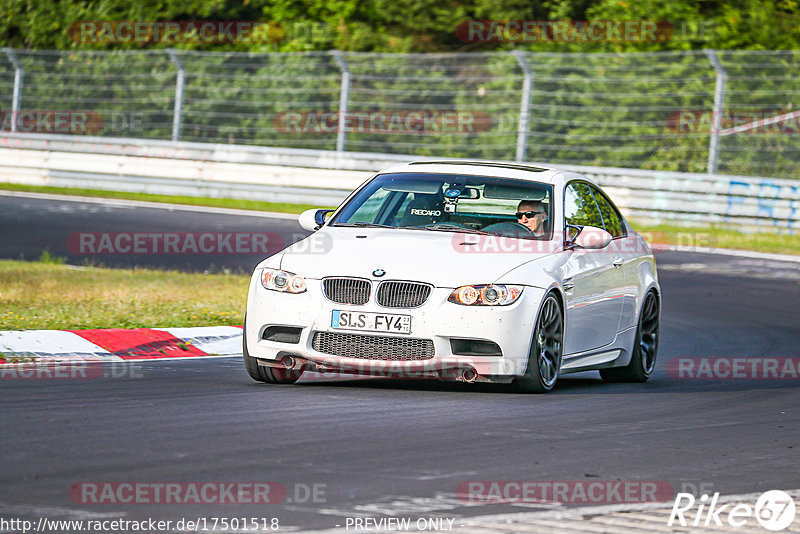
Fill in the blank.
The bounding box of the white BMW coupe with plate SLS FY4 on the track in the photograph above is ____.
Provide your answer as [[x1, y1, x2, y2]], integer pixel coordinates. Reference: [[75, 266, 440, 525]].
[[243, 161, 661, 393]]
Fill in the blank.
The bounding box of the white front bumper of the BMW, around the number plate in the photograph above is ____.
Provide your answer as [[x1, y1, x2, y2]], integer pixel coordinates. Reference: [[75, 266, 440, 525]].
[[244, 270, 545, 382]]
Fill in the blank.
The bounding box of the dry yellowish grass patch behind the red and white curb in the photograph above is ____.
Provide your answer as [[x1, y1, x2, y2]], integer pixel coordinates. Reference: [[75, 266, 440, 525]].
[[0, 260, 249, 330]]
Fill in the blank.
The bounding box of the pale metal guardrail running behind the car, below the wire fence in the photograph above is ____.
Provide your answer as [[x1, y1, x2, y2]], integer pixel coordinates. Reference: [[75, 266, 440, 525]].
[[0, 133, 800, 229]]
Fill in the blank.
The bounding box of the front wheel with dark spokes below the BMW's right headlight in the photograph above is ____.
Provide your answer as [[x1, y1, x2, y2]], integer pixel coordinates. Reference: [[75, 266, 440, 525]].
[[514, 293, 564, 393]]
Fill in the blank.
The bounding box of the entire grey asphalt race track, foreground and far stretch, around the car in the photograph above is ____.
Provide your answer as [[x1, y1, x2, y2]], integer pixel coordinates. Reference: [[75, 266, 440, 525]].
[[0, 196, 800, 531]]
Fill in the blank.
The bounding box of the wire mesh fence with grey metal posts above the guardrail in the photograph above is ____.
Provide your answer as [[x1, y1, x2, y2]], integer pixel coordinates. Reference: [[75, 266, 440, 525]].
[[0, 49, 800, 178]]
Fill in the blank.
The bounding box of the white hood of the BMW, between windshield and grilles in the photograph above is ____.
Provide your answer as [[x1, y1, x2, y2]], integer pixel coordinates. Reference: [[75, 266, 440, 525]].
[[280, 227, 555, 287]]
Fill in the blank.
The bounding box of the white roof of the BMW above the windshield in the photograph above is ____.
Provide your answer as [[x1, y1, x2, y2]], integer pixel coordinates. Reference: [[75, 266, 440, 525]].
[[372, 159, 594, 184]]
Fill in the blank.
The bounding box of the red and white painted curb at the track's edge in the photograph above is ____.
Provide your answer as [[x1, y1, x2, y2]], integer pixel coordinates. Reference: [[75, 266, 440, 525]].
[[0, 326, 242, 364]]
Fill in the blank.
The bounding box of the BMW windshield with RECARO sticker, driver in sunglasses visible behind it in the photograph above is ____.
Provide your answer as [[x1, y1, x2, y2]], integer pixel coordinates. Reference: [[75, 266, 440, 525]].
[[331, 173, 553, 239]]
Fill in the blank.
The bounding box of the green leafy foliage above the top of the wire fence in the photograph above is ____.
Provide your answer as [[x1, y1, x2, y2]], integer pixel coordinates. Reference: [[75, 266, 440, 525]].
[[0, 0, 800, 52]]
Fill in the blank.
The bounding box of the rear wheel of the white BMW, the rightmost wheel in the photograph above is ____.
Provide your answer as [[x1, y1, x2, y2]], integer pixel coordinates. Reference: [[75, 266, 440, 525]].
[[600, 290, 659, 382]]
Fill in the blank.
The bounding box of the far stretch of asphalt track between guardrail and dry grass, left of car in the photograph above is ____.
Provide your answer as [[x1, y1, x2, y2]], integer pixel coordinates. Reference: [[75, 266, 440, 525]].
[[0, 191, 308, 273]]
